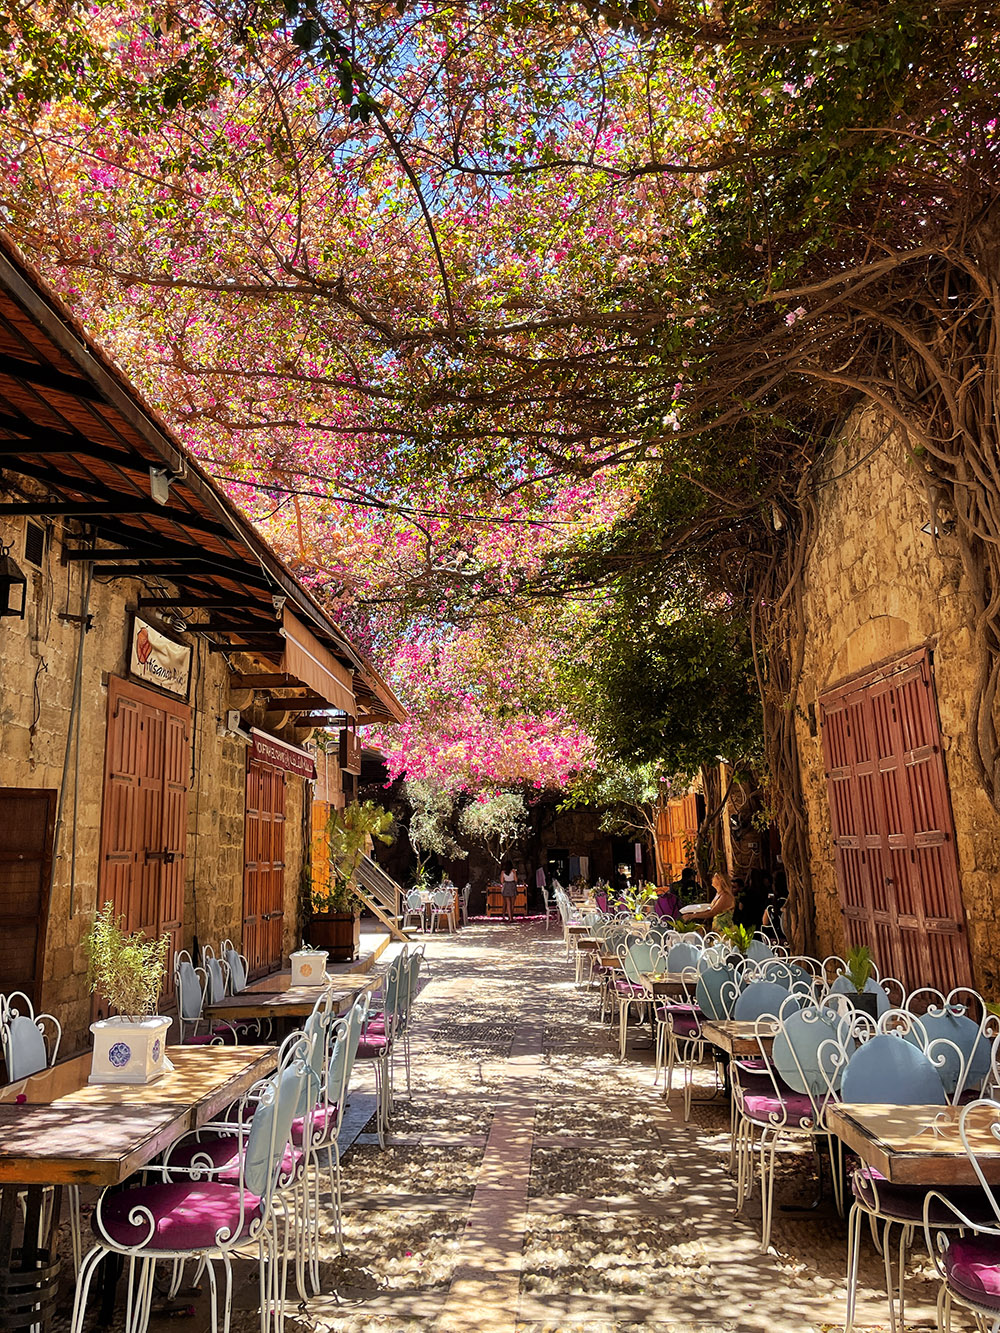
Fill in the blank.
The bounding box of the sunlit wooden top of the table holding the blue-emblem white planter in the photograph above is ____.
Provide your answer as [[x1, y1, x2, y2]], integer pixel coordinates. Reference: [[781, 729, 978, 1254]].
[[0, 1046, 277, 1185]]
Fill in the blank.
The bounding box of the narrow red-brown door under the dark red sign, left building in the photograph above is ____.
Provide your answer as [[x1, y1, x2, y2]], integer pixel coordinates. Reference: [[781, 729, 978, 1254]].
[[243, 756, 285, 973]]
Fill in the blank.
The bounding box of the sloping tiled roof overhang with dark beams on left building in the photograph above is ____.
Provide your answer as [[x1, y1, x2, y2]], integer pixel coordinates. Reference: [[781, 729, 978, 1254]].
[[0, 232, 407, 725]]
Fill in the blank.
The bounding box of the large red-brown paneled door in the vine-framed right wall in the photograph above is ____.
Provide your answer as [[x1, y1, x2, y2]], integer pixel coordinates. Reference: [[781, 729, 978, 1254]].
[[820, 651, 972, 990]]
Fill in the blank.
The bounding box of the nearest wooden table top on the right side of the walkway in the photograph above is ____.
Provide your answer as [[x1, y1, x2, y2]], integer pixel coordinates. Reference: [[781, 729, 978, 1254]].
[[827, 1102, 1000, 1189]]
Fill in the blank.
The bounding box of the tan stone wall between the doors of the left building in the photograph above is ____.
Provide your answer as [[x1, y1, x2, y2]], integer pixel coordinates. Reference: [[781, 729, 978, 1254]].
[[0, 519, 309, 1053]]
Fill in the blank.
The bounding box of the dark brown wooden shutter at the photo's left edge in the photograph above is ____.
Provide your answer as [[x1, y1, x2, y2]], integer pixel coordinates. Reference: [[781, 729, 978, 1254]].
[[0, 786, 56, 1008]]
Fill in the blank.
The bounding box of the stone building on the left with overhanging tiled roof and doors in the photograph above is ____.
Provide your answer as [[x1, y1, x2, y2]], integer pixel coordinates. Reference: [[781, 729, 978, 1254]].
[[0, 237, 403, 1050]]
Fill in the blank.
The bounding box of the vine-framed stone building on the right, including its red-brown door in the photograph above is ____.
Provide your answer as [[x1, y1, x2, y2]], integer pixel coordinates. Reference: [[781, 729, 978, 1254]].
[[795, 411, 1000, 994]]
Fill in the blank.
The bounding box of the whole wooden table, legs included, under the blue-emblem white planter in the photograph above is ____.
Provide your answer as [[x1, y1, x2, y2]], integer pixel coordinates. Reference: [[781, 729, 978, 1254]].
[[0, 1046, 277, 1328]]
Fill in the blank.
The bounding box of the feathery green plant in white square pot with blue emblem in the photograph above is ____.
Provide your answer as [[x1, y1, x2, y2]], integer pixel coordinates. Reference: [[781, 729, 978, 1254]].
[[84, 902, 173, 1084]]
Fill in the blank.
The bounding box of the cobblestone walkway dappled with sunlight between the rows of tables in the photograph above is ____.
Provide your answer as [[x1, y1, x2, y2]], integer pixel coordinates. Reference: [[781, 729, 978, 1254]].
[[68, 922, 967, 1333]]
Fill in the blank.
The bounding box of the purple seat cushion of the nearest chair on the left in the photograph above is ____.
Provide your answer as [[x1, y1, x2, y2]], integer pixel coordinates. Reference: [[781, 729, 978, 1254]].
[[93, 1181, 260, 1250]]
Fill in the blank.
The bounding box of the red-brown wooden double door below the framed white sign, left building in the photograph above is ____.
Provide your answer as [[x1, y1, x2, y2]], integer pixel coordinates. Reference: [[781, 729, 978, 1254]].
[[97, 676, 191, 996]]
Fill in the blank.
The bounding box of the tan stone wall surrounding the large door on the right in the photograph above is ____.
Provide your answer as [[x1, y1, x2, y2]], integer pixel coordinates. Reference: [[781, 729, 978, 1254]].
[[796, 412, 1000, 993]]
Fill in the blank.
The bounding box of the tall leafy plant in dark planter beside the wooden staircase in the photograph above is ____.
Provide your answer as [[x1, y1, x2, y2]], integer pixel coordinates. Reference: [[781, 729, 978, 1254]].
[[307, 801, 392, 962]]
